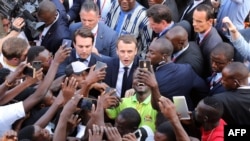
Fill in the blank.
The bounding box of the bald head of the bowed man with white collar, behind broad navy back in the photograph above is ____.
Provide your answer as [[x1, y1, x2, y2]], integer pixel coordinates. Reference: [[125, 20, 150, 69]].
[[166, 26, 188, 52]]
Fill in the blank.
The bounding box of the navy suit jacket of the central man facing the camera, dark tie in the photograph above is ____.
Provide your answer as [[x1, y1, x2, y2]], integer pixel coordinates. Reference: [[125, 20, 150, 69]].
[[104, 56, 139, 97]]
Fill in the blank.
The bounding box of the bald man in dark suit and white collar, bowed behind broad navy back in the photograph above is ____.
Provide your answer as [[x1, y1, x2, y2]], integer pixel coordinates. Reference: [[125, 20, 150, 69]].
[[166, 26, 203, 76]]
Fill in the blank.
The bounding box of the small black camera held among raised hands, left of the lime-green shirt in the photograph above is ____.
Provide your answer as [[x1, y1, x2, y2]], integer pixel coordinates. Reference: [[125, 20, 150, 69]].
[[77, 97, 97, 111]]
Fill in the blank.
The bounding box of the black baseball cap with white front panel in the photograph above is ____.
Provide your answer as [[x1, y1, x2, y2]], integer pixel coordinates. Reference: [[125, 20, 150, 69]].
[[65, 61, 89, 76]]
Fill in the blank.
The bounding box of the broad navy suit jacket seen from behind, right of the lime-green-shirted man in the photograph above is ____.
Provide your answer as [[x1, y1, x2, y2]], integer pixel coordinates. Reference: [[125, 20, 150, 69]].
[[155, 63, 209, 110]]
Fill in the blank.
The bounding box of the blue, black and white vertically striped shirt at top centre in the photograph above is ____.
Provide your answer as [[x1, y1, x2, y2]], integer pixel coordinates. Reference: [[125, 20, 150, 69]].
[[106, 1, 152, 57]]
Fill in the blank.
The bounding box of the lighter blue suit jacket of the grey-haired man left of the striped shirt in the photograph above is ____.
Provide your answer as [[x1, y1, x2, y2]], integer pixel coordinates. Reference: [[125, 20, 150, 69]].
[[70, 22, 118, 58]]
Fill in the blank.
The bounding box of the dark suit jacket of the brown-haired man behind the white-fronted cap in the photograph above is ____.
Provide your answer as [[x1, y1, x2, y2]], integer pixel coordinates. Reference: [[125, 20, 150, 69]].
[[56, 49, 103, 78]]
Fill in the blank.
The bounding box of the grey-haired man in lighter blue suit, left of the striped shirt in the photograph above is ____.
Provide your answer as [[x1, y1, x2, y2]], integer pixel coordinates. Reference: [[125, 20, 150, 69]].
[[70, 1, 118, 58]]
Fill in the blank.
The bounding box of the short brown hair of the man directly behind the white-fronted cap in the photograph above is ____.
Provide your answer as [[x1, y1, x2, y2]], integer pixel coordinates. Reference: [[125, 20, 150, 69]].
[[73, 27, 95, 43]]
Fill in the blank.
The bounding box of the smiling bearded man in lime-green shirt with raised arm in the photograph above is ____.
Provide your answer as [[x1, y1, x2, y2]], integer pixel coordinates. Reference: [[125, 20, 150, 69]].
[[106, 70, 157, 131]]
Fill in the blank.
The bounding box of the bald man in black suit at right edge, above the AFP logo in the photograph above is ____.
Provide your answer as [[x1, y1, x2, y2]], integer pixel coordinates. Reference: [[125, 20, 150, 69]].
[[213, 62, 250, 125]]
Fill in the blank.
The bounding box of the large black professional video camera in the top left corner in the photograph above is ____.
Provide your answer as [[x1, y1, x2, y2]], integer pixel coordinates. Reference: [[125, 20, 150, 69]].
[[0, 0, 44, 38]]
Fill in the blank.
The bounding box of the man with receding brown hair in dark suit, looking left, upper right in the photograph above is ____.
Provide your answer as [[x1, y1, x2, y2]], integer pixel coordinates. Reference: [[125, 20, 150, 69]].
[[193, 4, 222, 77]]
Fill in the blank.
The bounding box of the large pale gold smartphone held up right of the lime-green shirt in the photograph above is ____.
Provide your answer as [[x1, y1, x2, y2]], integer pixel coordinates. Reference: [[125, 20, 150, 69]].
[[173, 96, 190, 120]]
